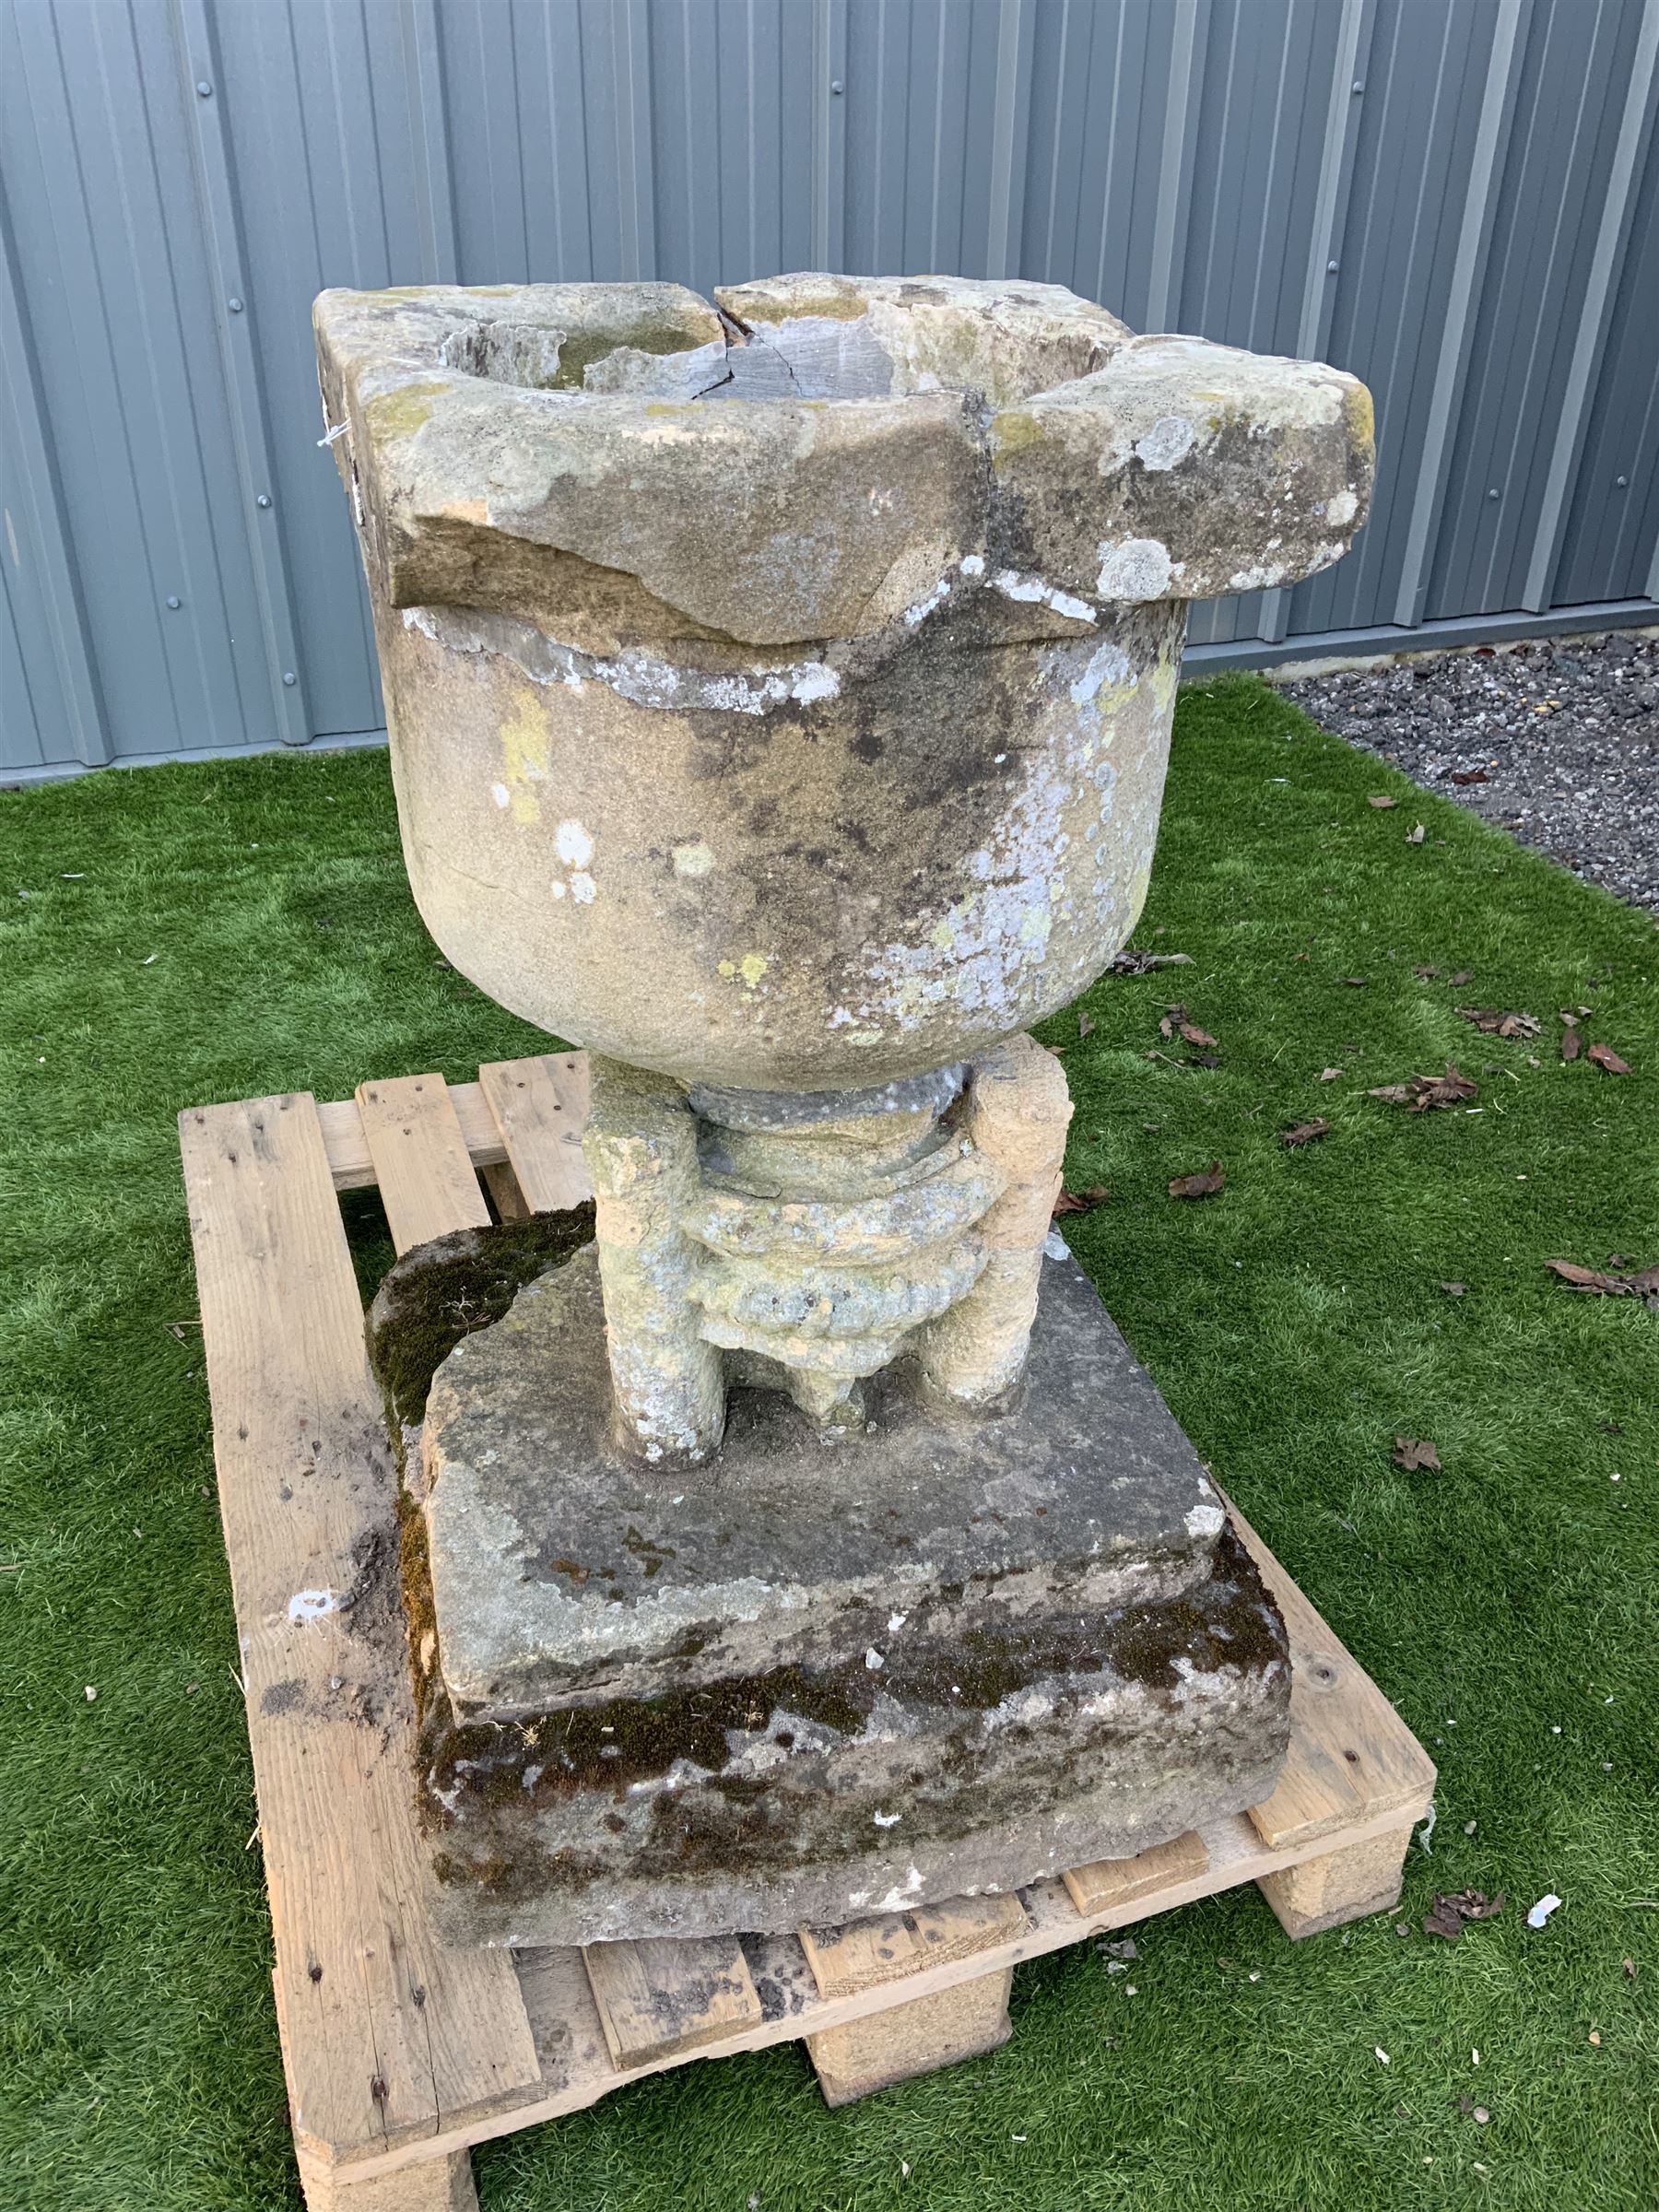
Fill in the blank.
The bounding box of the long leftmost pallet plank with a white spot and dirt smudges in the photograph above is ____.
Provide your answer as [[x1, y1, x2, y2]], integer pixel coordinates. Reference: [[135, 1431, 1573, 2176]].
[[179, 1093, 540, 2163]]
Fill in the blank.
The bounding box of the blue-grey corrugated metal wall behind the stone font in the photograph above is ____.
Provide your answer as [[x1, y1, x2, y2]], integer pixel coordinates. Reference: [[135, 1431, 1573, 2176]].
[[0, 0, 1659, 776]]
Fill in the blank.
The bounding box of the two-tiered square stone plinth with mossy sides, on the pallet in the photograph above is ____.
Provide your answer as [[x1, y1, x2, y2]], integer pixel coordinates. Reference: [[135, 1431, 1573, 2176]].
[[422, 1252, 1289, 1945]]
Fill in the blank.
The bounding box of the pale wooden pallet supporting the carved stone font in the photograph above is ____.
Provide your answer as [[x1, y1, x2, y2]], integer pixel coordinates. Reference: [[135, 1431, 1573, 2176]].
[[179, 1055, 1436, 2212]]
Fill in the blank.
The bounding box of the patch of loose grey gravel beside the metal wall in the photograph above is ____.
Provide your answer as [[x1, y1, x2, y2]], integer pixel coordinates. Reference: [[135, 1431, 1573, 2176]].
[[1281, 630, 1659, 913]]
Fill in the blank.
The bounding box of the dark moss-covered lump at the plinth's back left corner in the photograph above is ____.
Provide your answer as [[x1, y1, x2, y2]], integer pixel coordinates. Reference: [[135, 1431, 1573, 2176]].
[[367, 1204, 593, 1436]]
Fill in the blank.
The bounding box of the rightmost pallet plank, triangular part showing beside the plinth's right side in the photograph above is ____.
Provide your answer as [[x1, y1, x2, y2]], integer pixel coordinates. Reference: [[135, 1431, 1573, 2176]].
[[1228, 1500, 1436, 1849]]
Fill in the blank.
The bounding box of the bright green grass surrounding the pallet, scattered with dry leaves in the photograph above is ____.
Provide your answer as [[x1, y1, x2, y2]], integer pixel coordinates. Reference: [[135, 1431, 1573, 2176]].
[[0, 679, 1659, 2212]]
